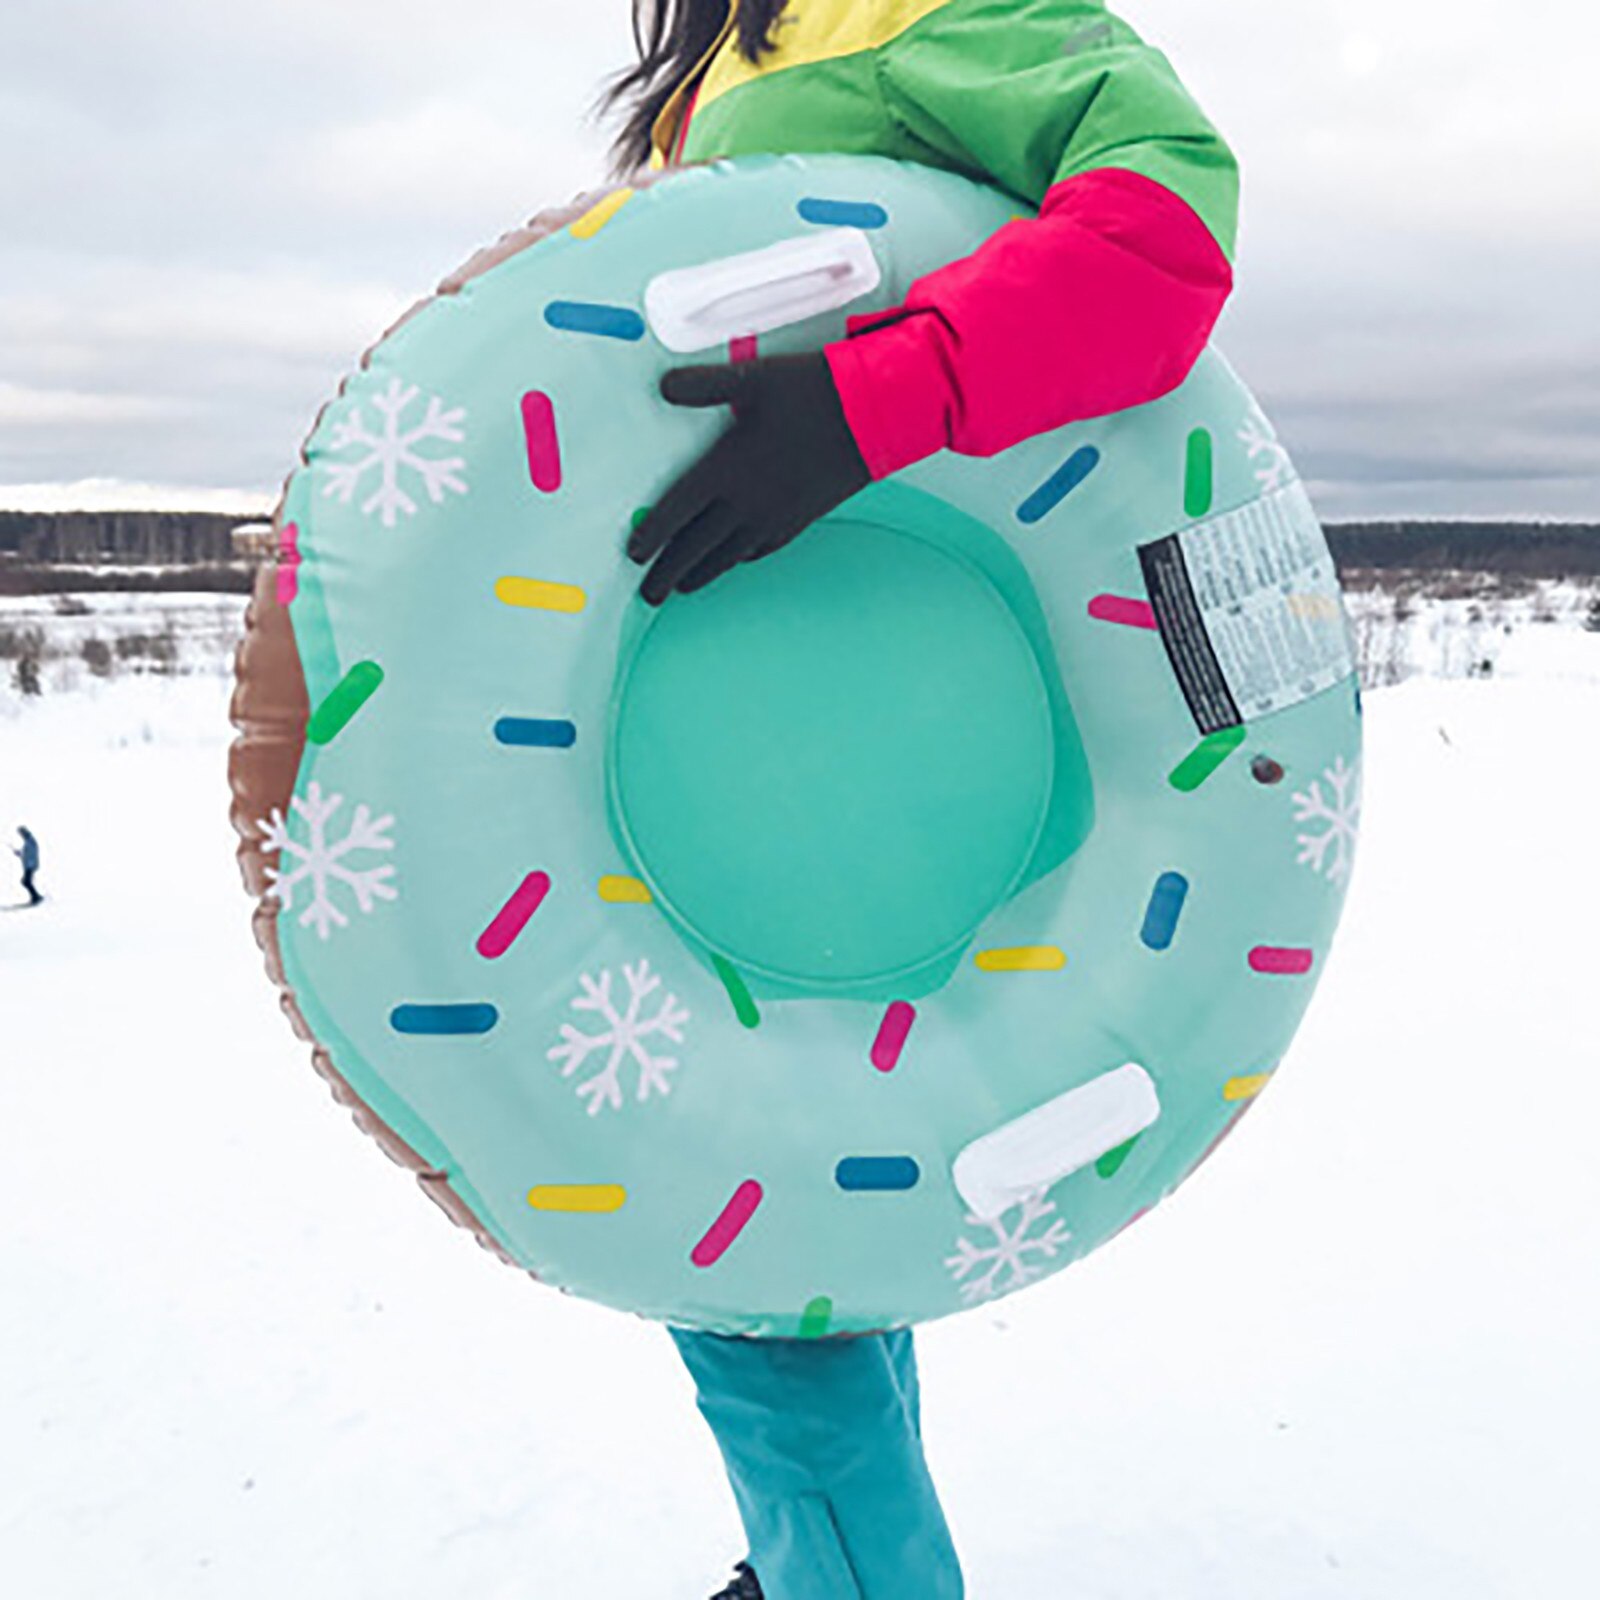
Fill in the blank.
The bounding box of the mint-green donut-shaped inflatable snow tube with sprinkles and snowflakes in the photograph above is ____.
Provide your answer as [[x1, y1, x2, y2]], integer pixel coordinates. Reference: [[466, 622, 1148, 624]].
[[232, 158, 1360, 1336]]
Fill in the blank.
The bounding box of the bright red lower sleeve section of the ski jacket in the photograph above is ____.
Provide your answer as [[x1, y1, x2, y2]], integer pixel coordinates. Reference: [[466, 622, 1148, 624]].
[[827, 168, 1234, 478]]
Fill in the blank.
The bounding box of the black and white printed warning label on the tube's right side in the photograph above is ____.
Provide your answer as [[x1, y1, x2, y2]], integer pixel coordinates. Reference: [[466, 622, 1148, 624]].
[[1139, 483, 1355, 733]]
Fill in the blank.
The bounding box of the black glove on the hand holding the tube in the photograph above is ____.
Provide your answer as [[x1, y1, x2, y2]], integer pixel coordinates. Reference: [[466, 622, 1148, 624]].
[[627, 354, 870, 605]]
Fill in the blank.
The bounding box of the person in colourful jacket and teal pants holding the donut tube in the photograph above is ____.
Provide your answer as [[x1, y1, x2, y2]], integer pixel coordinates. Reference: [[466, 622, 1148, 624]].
[[610, 0, 1238, 1600]]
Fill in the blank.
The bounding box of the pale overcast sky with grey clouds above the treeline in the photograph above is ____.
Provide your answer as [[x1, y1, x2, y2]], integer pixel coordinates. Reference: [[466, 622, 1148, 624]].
[[0, 0, 1600, 520]]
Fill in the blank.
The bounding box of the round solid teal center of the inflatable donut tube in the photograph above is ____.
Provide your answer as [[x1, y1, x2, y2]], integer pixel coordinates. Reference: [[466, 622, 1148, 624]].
[[610, 480, 1086, 995]]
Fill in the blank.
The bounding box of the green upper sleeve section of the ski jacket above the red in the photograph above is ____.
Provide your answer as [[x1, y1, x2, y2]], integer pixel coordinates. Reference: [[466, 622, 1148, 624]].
[[878, 0, 1238, 259]]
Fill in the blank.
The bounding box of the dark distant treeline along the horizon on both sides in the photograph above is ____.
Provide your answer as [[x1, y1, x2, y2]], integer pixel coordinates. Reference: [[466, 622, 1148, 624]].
[[0, 510, 1600, 594]]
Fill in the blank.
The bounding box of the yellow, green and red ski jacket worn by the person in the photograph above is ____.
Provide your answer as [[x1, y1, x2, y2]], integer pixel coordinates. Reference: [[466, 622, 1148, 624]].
[[654, 0, 1238, 477]]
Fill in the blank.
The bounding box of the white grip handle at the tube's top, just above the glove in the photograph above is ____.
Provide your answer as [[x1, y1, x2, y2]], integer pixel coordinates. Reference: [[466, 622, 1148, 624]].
[[645, 227, 883, 355]]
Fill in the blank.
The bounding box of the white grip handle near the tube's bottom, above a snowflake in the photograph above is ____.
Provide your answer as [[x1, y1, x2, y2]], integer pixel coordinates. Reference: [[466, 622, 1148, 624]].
[[952, 1061, 1162, 1222]]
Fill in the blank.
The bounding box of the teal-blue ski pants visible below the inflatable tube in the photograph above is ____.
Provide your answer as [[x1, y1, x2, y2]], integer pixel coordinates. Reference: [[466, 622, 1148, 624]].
[[672, 1328, 963, 1600]]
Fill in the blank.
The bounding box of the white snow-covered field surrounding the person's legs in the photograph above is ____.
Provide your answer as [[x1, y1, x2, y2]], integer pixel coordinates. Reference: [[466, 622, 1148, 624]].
[[0, 604, 1600, 1600]]
